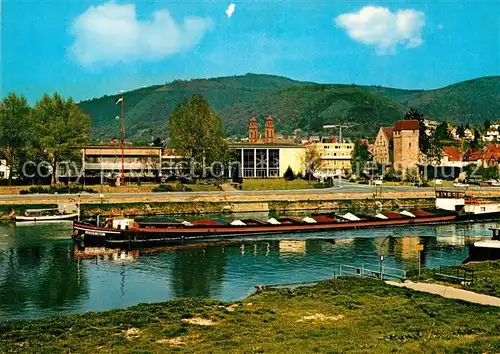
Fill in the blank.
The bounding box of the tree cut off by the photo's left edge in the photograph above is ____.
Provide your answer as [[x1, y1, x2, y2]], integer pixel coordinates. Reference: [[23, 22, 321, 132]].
[[0, 93, 31, 185]]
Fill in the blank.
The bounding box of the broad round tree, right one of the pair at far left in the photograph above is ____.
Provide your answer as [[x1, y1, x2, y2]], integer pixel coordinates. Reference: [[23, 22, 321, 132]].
[[32, 93, 91, 184]]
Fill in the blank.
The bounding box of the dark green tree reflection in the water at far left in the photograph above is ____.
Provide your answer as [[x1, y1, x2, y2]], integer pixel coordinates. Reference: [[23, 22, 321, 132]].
[[0, 221, 88, 317]]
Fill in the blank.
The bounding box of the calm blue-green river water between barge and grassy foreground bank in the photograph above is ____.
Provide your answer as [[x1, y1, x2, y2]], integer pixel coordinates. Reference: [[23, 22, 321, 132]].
[[0, 223, 498, 320]]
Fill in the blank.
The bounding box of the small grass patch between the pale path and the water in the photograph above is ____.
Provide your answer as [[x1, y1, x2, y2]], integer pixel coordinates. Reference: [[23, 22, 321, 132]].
[[412, 261, 500, 297]]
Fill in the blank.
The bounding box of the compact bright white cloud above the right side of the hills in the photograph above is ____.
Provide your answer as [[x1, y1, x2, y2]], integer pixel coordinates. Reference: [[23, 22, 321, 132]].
[[335, 6, 425, 55]]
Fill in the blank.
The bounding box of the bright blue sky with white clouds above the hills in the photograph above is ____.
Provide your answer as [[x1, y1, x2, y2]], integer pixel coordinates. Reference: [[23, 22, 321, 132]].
[[1, 0, 500, 103]]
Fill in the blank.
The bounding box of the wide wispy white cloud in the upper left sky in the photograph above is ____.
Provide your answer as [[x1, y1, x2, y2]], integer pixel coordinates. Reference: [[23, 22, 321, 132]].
[[70, 1, 213, 67]]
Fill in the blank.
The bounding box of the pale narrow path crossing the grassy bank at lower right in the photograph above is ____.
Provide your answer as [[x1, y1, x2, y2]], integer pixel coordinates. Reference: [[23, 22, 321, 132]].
[[386, 281, 500, 307]]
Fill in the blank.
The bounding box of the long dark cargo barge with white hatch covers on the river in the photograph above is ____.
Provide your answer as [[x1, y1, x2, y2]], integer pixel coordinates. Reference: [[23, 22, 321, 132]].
[[72, 191, 500, 247]]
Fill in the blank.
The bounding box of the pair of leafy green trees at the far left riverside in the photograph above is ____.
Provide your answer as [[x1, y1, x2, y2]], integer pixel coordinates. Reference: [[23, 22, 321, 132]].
[[0, 93, 91, 185]]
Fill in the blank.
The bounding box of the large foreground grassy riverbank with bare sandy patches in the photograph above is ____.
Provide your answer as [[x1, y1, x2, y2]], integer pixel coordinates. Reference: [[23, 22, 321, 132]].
[[0, 278, 500, 353]]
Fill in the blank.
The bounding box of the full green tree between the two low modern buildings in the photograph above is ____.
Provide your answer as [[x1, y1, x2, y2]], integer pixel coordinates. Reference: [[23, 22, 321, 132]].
[[169, 94, 229, 176]]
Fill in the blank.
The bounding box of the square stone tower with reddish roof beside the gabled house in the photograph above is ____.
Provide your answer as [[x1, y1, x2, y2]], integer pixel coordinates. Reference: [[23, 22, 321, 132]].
[[393, 119, 420, 174]]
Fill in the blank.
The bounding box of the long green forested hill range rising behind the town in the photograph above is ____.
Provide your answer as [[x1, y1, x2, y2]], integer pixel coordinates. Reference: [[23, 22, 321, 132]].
[[79, 74, 500, 141]]
